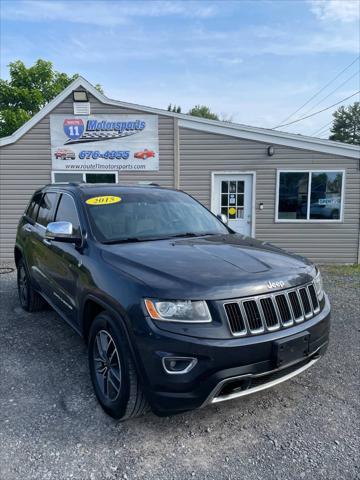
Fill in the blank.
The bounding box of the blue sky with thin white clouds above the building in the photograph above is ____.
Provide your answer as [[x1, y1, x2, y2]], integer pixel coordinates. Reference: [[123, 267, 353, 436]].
[[0, 0, 360, 138]]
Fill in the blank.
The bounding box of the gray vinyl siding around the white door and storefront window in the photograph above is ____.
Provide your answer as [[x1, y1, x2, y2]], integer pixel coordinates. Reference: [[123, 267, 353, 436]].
[[180, 128, 360, 263]]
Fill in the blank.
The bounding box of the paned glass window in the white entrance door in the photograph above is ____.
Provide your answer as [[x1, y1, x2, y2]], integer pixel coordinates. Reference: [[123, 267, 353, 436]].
[[220, 180, 245, 220]]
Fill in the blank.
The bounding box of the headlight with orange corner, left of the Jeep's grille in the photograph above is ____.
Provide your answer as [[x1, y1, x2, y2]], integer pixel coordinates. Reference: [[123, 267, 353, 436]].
[[145, 298, 211, 323]]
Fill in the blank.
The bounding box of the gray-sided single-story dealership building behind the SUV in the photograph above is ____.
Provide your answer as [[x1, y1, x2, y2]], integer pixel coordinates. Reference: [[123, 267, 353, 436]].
[[0, 77, 360, 264]]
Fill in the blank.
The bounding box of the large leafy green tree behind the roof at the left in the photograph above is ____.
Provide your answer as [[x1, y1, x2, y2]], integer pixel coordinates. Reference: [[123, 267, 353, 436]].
[[0, 59, 103, 137]]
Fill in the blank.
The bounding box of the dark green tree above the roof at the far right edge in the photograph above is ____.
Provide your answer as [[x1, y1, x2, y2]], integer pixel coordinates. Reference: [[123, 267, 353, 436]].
[[329, 102, 360, 145]]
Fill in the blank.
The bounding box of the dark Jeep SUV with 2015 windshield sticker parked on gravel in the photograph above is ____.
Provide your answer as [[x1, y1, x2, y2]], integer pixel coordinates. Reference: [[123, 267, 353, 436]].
[[15, 184, 330, 419]]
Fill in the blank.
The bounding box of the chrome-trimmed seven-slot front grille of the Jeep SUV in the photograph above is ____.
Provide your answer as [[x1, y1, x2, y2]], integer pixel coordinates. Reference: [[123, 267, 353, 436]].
[[224, 283, 320, 336]]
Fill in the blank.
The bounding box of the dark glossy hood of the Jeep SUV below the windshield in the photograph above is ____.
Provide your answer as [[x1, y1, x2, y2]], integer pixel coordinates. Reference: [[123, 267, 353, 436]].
[[102, 234, 314, 300]]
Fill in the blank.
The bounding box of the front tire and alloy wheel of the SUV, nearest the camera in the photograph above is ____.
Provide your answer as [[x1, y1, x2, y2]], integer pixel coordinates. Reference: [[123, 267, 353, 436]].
[[88, 312, 149, 421]]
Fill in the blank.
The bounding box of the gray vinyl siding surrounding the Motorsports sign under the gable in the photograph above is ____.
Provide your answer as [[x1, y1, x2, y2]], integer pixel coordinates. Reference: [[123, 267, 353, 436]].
[[0, 90, 174, 262]]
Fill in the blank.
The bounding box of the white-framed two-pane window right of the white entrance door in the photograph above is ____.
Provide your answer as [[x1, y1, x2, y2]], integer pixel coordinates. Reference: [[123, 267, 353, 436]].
[[277, 171, 343, 221]]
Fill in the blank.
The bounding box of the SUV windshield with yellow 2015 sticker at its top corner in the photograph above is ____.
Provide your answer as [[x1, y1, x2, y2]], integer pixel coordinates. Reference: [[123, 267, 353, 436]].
[[85, 189, 229, 243]]
